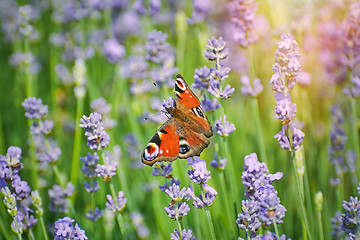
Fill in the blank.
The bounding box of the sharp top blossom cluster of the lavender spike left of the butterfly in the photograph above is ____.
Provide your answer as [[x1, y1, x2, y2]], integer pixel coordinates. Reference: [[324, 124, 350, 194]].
[[80, 112, 110, 150]]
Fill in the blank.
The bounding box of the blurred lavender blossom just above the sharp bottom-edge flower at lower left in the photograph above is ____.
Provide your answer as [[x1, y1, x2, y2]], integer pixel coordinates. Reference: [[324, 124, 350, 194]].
[[49, 182, 74, 213]]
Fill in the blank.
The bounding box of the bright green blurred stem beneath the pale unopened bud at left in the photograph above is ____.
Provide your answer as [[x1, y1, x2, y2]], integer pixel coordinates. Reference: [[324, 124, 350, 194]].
[[70, 98, 84, 187]]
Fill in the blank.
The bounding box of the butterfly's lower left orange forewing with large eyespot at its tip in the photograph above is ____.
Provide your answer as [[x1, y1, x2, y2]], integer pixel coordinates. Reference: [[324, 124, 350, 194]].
[[141, 119, 179, 166]]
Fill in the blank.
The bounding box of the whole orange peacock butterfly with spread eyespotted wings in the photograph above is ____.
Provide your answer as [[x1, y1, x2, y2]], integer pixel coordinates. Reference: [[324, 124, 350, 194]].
[[141, 74, 213, 166]]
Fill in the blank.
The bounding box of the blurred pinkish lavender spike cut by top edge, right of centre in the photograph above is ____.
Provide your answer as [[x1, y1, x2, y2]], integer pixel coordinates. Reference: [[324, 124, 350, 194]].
[[226, 0, 258, 47]]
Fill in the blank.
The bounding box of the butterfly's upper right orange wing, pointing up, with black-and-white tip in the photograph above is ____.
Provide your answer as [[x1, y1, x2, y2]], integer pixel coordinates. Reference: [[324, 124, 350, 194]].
[[175, 74, 213, 138]]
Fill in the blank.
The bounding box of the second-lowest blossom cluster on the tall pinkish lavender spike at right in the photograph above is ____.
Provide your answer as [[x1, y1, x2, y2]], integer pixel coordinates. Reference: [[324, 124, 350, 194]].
[[275, 92, 296, 125]]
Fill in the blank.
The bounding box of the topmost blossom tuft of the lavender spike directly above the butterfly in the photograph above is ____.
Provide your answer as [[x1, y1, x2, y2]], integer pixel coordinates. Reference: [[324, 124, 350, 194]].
[[205, 37, 229, 61]]
